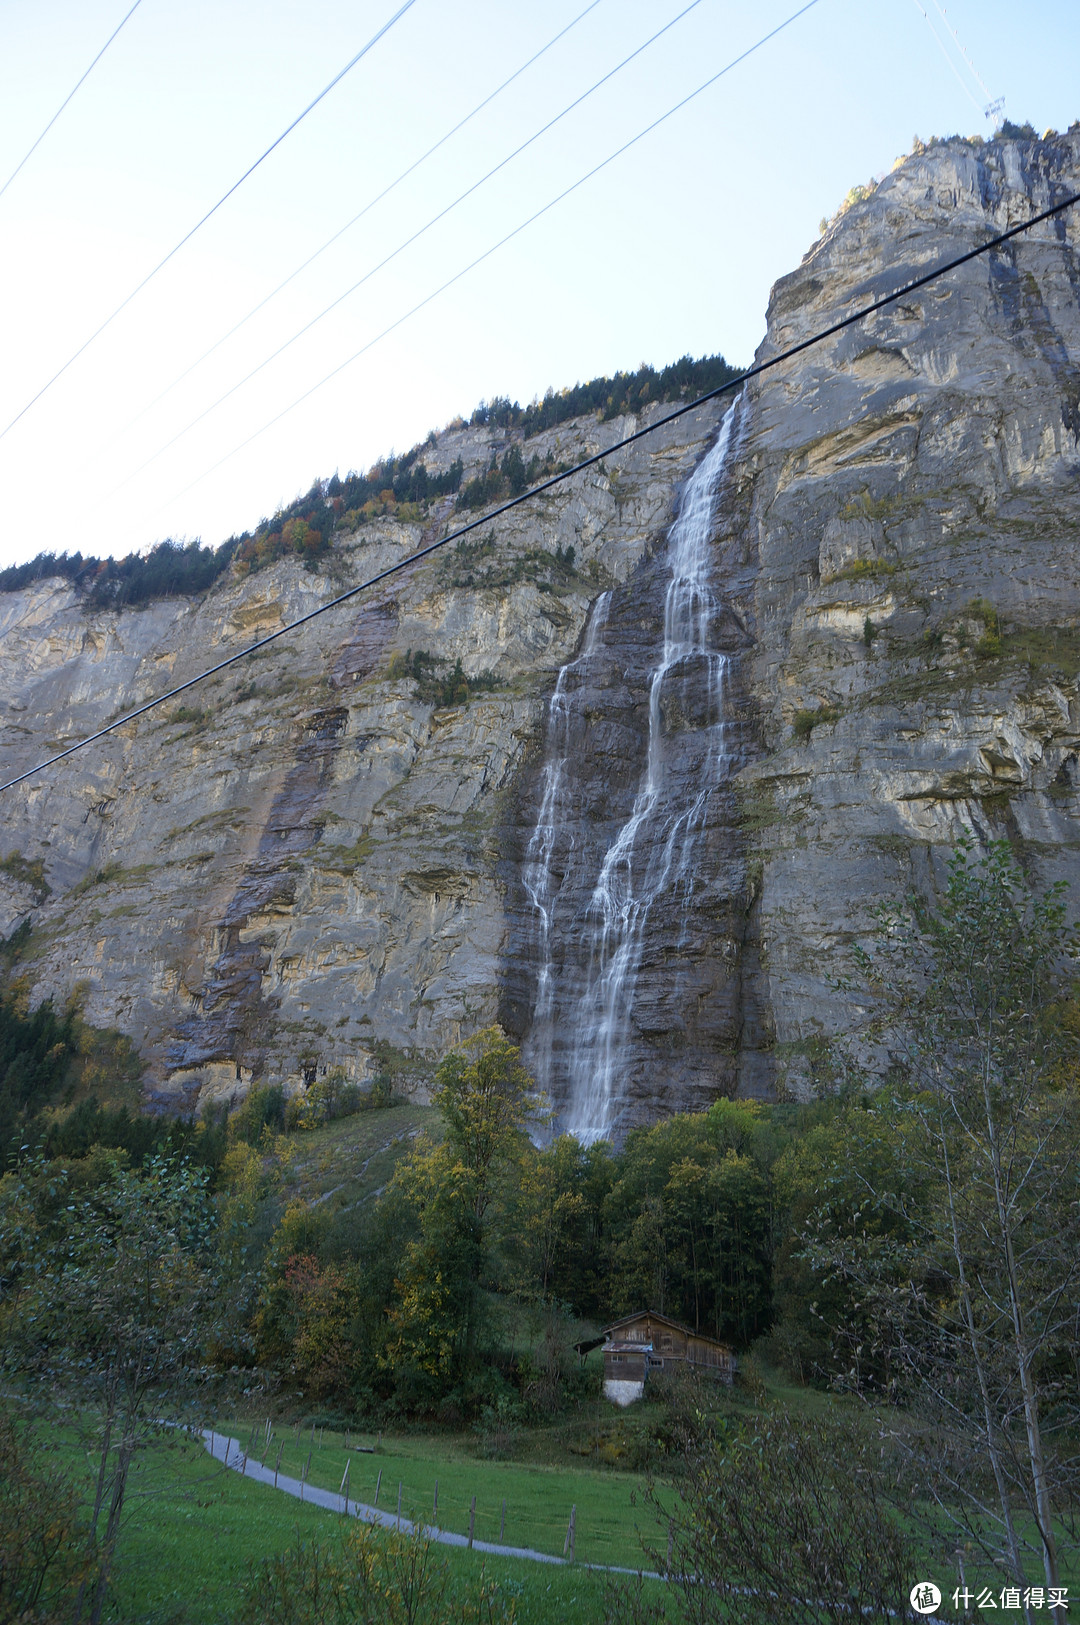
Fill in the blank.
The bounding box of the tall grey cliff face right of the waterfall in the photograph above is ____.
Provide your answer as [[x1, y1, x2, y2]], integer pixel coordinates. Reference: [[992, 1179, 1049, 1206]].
[[729, 127, 1080, 1095]]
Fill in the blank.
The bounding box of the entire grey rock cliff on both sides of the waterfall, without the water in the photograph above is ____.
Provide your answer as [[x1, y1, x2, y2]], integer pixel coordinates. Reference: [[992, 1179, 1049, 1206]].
[[0, 128, 1080, 1133]]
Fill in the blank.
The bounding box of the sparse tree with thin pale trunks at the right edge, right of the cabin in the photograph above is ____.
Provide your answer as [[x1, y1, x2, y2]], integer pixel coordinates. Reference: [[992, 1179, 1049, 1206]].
[[806, 842, 1080, 1605]]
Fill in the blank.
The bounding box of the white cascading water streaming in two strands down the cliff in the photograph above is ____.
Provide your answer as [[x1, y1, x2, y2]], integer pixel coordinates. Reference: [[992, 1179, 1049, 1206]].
[[523, 410, 737, 1144]]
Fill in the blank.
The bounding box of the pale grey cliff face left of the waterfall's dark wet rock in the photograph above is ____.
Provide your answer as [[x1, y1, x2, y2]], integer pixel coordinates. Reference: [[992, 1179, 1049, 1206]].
[[0, 408, 719, 1107]]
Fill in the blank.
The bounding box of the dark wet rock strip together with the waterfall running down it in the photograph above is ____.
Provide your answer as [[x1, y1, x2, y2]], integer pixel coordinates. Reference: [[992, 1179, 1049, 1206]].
[[502, 406, 755, 1139]]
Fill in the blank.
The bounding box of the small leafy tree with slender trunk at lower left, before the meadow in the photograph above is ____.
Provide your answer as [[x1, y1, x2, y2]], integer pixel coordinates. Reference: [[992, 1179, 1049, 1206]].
[[0, 1154, 218, 1625]]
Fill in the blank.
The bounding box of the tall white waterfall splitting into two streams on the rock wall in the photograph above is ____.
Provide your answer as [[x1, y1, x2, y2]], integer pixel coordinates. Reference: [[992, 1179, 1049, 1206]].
[[523, 410, 737, 1142]]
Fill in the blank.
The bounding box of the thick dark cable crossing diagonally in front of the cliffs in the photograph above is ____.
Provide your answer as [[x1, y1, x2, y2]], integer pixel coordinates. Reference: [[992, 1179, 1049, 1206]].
[[0, 192, 1080, 793]]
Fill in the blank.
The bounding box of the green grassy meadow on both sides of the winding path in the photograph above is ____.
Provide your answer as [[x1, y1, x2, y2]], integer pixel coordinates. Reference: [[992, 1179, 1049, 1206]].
[[50, 1428, 648, 1625]]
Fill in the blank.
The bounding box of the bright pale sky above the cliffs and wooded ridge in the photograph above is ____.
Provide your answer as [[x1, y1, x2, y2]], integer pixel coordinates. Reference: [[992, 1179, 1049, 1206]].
[[0, 0, 1080, 566]]
